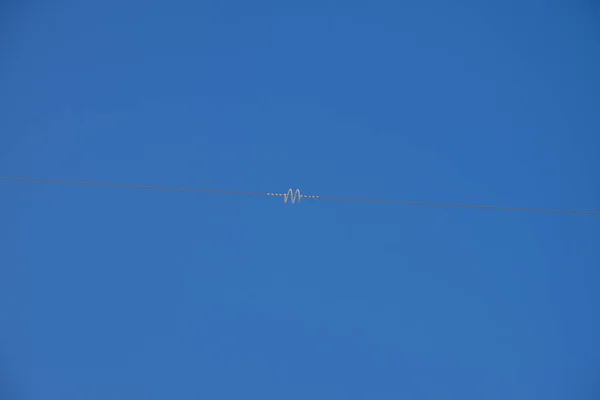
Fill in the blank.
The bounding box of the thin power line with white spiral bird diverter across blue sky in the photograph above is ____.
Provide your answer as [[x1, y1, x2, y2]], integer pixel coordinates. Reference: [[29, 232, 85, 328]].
[[0, 177, 600, 215]]
